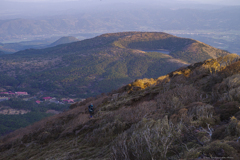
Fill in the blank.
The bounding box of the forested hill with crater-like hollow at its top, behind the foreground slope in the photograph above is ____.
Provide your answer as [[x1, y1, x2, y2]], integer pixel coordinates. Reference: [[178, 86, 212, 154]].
[[0, 32, 229, 98]]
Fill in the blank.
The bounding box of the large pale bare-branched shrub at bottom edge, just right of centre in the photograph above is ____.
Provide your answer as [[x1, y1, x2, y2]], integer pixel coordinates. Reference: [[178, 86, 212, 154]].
[[110, 116, 181, 160]]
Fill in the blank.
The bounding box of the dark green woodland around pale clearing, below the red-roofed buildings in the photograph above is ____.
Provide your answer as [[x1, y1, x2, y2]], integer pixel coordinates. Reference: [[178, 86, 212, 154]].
[[0, 98, 69, 135]]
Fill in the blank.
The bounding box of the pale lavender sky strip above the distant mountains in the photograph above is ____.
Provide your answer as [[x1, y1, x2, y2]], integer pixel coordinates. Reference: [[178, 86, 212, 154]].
[[0, 0, 240, 19]]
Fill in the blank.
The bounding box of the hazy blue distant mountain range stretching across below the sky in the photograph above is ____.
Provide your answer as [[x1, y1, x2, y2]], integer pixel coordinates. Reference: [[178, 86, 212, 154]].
[[0, 6, 240, 42]]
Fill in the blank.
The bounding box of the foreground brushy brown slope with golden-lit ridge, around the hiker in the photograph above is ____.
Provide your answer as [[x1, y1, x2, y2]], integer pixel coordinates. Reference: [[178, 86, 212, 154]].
[[0, 54, 240, 160]]
